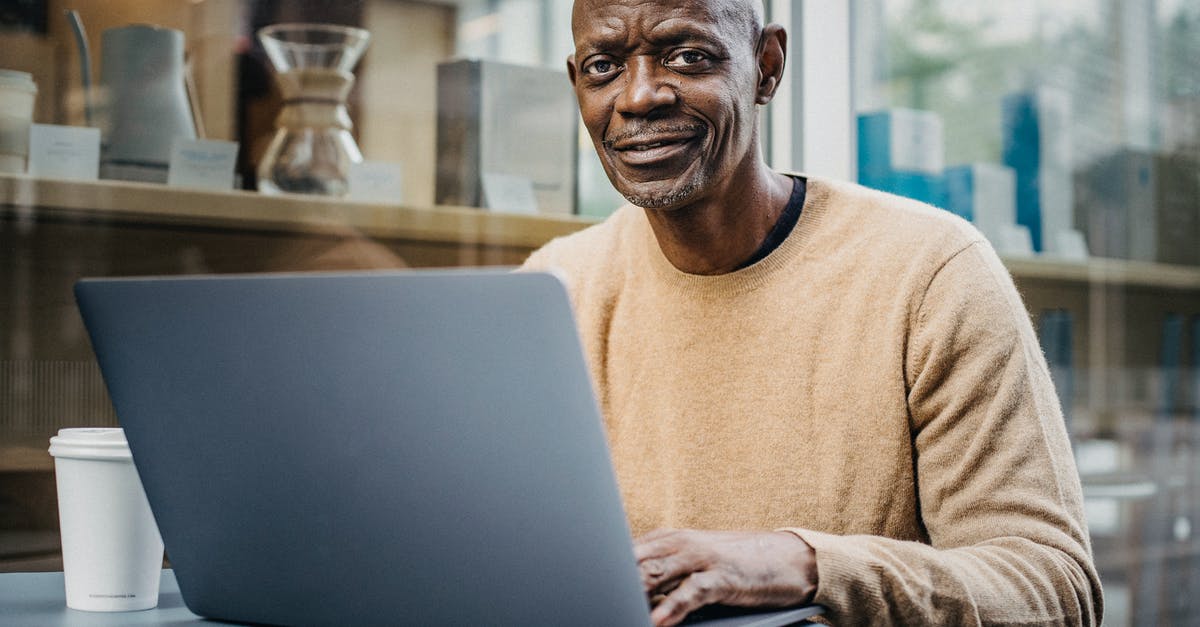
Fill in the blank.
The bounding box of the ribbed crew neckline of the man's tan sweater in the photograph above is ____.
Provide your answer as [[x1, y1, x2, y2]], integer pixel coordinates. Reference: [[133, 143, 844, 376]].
[[635, 172, 832, 298]]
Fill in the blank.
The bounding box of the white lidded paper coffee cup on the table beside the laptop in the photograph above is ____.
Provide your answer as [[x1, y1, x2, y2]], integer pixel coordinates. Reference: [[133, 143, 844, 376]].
[[50, 429, 162, 611]]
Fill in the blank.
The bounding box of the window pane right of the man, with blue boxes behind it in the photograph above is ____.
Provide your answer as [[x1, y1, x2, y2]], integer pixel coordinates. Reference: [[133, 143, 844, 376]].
[[853, 0, 1200, 625]]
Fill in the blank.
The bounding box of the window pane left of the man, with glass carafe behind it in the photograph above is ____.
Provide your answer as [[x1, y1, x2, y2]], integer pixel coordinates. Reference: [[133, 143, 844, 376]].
[[0, 0, 622, 571]]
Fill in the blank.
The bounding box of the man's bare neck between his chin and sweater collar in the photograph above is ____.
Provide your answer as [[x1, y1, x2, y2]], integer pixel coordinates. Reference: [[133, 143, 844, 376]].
[[646, 163, 792, 275]]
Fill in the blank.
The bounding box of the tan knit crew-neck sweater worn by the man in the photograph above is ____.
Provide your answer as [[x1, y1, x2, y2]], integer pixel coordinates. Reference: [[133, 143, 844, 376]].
[[526, 174, 1102, 625]]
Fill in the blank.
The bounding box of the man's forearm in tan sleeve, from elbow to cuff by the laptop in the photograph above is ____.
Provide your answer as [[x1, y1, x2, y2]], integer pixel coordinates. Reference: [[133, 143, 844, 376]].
[[794, 530, 1100, 626]]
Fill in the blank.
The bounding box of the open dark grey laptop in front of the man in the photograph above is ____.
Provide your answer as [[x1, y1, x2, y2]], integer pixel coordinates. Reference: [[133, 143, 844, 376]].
[[76, 270, 820, 627]]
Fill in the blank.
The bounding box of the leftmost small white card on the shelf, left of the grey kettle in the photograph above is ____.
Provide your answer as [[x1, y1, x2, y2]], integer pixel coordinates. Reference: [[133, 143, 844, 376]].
[[29, 124, 100, 180]]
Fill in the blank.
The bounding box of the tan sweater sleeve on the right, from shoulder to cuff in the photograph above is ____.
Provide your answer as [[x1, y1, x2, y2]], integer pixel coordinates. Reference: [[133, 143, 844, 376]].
[[788, 243, 1103, 625]]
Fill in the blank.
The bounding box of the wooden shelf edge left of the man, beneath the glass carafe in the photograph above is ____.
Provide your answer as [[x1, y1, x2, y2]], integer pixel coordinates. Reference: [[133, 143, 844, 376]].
[[0, 174, 593, 249]]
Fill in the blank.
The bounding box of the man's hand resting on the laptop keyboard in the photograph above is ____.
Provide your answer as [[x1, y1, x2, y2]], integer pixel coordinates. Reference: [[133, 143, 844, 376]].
[[634, 530, 817, 627]]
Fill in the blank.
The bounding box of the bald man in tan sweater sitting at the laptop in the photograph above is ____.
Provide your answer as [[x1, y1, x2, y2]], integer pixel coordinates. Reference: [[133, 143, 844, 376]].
[[526, 0, 1102, 625]]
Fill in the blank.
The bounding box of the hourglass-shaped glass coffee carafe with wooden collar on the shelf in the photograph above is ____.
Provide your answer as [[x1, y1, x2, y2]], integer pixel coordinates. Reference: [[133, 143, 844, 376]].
[[258, 24, 371, 196]]
